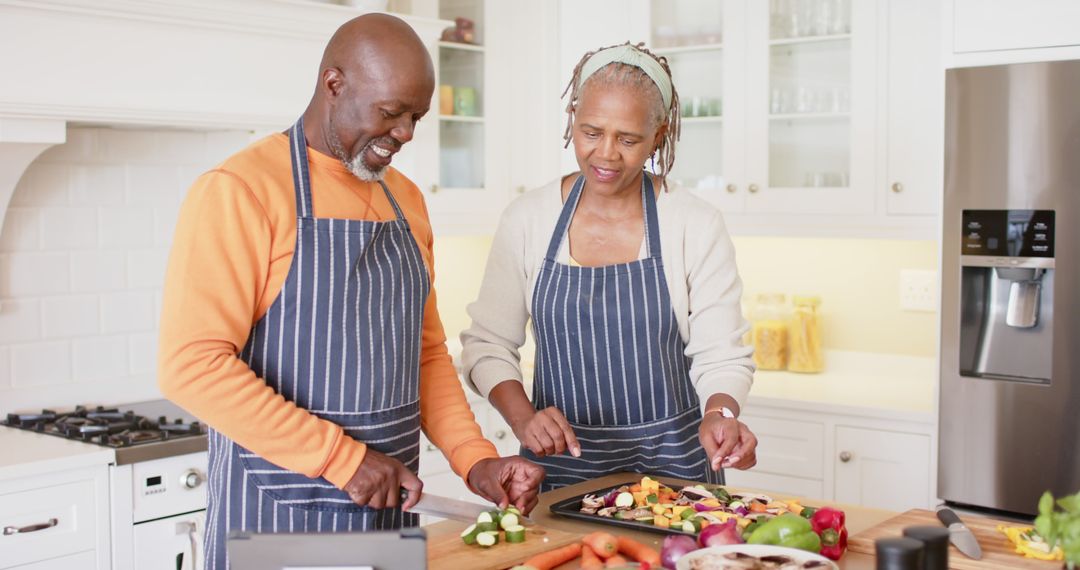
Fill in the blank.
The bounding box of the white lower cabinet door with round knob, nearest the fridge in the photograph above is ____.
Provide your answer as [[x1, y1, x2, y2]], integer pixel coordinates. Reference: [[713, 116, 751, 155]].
[[833, 425, 931, 511]]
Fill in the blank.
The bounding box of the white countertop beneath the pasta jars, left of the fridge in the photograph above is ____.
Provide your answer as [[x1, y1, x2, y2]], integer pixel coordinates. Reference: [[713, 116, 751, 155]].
[[746, 351, 937, 422]]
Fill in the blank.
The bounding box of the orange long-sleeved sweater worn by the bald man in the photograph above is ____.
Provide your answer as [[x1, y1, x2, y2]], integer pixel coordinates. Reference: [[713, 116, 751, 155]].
[[158, 133, 498, 488]]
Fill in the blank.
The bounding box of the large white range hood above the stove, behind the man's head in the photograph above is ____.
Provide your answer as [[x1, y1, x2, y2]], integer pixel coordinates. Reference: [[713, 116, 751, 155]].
[[0, 0, 449, 235]]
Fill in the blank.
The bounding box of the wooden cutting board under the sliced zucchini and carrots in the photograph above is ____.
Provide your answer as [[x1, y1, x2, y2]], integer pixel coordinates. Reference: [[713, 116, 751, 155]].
[[428, 523, 581, 570]]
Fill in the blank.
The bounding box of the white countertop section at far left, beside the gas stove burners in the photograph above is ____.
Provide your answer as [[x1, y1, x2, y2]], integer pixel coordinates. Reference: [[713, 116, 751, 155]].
[[0, 426, 116, 479]]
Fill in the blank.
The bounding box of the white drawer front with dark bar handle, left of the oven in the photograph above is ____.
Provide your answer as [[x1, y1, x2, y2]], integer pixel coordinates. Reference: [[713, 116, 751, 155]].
[[0, 479, 98, 568]]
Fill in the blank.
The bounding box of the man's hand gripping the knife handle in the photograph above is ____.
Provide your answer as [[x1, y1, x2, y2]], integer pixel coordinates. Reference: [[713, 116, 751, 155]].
[[345, 447, 423, 511]]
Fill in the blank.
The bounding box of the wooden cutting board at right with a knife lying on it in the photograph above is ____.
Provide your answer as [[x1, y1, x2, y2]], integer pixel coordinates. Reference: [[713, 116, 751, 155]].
[[848, 508, 1062, 570]]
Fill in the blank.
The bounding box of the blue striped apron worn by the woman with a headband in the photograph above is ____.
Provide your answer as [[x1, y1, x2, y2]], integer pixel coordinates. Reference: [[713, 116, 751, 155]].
[[522, 176, 724, 491]]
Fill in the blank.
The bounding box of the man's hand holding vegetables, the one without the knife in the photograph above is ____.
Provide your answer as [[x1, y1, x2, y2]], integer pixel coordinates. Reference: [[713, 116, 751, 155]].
[[469, 456, 543, 515]]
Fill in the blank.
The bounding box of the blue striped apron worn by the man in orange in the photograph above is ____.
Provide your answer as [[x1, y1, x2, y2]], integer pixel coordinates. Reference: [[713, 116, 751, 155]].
[[205, 119, 431, 570]]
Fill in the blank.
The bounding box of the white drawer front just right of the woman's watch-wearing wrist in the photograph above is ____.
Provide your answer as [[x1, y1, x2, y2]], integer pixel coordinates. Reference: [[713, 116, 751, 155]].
[[739, 413, 825, 479]]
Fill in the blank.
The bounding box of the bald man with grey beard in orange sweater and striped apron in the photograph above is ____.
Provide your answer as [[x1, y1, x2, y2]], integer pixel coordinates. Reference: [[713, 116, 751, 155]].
[[159, 14, 543, 570]]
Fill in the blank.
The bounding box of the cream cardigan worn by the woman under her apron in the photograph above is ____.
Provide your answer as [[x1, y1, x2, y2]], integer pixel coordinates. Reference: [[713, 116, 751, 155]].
[[461, 180, 754, 407]]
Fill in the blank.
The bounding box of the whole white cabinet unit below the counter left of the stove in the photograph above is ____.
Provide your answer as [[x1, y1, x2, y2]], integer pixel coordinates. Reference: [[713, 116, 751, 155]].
[[0, 465, 109, 570]]
